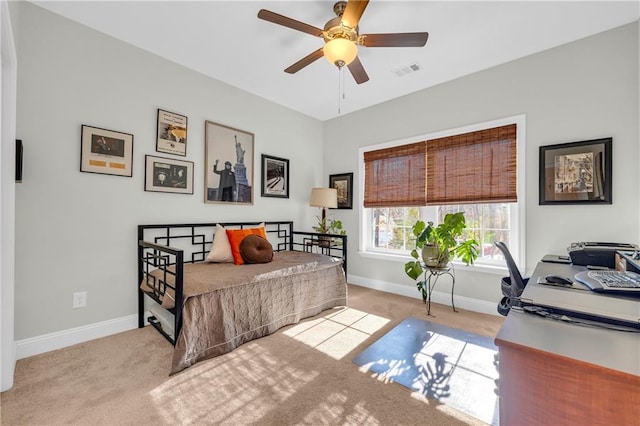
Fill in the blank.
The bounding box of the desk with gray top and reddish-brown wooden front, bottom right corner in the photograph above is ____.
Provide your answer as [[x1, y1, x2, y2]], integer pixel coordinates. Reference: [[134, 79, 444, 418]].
[[495, 265, 640, 426]]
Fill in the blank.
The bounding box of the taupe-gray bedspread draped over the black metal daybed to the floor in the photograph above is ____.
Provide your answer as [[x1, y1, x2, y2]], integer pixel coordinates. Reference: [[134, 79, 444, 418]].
[[143, 251, 347, 374]]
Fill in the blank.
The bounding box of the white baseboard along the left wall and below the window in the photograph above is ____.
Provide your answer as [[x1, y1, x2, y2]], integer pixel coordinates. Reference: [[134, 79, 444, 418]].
[[16, 274, 498, 359]]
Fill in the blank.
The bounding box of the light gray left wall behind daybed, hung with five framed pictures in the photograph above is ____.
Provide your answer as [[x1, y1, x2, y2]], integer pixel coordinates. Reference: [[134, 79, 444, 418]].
[[15, 2, 324, 340]]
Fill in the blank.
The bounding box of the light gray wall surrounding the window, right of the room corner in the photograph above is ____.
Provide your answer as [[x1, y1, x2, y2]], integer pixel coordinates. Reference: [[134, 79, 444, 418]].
[[325, 22, 640, 301]]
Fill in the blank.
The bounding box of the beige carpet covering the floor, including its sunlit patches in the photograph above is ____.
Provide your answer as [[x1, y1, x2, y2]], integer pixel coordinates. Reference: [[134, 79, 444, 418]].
[[0, 286, 502, 425]]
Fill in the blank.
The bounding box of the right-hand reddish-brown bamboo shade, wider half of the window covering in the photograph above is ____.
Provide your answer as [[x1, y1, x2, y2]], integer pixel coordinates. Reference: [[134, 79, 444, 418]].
[[427, 124, 517, 205]]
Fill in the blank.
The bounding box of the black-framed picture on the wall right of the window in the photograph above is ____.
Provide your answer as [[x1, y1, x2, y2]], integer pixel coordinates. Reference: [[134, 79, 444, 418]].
[[540, 138, 612, 204]]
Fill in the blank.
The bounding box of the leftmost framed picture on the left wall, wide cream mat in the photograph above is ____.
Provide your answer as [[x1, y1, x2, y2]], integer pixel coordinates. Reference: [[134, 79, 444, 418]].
[[80, 124, 133, 177]]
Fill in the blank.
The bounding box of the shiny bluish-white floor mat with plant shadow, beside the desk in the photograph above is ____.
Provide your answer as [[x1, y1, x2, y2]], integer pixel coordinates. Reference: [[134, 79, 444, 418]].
[[353, 317, 499, 425]]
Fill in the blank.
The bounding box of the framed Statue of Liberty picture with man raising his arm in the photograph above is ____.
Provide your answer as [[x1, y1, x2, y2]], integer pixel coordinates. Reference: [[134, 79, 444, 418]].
[[204, 121, 254, 204]]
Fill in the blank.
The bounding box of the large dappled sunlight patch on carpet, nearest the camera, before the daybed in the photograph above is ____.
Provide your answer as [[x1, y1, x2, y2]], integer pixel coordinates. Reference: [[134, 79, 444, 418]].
[[150, 343, 320, 425]]
